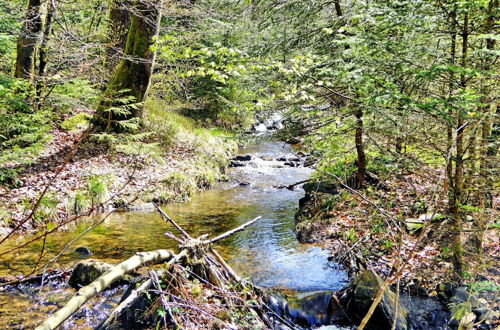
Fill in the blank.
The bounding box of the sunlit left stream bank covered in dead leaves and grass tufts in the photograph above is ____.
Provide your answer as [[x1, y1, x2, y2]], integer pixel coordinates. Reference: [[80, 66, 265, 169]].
[[0, 109, 237, 234]]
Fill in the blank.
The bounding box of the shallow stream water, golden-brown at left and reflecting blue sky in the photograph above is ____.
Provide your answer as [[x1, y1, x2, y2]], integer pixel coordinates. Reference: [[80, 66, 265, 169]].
[[0, 141, 347, 327]]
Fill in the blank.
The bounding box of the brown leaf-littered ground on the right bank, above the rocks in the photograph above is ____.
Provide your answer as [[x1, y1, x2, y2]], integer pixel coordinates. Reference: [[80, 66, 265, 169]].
[[296, 167, 500, 296]]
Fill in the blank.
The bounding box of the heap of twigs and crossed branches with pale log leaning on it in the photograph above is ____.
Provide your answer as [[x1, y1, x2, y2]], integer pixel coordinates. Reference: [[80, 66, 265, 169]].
[[37, 205, 287, 330]]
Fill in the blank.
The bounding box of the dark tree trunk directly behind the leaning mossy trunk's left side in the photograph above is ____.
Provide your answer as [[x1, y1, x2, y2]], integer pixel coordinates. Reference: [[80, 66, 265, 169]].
[[106, 0, 131, 71]]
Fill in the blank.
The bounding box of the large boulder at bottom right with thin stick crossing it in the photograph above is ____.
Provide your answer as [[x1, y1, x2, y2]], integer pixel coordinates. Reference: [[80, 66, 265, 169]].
[[350, 270, 409, 330]]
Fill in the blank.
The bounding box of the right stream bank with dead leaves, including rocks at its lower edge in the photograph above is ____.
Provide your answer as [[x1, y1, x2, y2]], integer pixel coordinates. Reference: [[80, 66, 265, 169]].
[[295, 167, 500, 329]]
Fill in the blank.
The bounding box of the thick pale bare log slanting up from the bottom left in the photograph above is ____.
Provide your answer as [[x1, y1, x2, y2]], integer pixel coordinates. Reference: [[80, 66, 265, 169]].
[[36, 250, 176, 330]]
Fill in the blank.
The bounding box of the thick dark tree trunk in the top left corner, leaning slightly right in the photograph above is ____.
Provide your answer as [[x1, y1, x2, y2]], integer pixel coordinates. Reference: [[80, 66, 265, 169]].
[[14, 0, 43, 81]]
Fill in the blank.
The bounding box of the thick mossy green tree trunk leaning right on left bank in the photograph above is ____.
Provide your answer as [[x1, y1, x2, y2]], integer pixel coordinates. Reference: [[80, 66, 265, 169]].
[[95, 0, 161, 131]]
